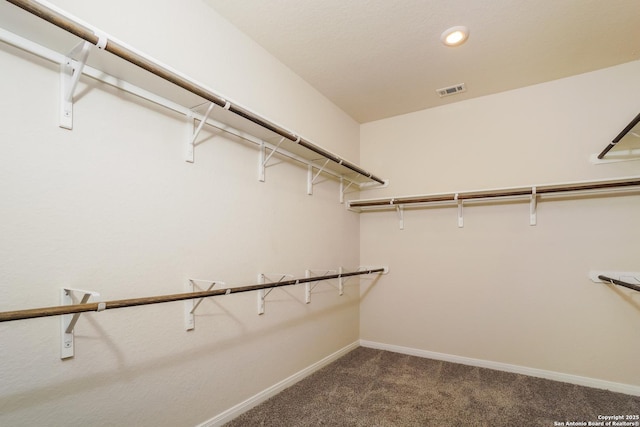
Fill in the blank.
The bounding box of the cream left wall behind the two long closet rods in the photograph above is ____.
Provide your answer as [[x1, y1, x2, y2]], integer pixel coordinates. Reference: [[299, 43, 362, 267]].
[[0, 0, 359, 426]]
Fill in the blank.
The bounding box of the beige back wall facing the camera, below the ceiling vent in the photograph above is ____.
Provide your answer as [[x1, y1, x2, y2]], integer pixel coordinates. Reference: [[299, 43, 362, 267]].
[[360, 62, 640, 386]]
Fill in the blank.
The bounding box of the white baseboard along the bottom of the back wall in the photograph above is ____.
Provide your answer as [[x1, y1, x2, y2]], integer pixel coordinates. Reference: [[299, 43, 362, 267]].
[[360, 340, 640, 396]]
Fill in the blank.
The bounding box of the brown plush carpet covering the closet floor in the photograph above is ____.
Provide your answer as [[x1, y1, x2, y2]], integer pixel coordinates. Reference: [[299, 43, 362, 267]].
[[225, 347, 640, 427]]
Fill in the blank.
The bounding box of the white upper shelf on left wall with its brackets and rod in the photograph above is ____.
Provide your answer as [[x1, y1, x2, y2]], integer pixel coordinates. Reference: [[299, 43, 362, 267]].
[[0, 0, 387, 193]]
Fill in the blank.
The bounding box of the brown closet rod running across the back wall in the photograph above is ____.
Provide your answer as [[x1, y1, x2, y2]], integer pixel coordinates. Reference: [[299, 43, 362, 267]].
[[349, 177, 640, 208]]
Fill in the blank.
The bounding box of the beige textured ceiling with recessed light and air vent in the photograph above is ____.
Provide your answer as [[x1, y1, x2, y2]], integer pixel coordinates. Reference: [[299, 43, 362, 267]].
[[204, 0, 640, 123]]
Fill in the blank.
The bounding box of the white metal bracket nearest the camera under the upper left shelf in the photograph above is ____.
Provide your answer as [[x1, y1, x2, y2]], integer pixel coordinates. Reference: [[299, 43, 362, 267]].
[[60, 41, 92, 130]]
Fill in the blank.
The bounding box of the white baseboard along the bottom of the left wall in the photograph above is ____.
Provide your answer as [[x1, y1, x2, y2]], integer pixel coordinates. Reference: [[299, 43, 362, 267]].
[[197, 341, 360, 427]]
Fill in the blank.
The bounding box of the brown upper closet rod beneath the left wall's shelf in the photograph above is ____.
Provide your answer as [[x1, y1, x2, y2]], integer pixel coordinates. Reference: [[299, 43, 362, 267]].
[[7, 0, 385, 184]]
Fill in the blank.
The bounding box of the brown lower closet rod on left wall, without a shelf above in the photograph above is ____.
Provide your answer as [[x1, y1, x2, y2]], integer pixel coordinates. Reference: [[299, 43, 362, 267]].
[[0, 267, 385, 322]]
